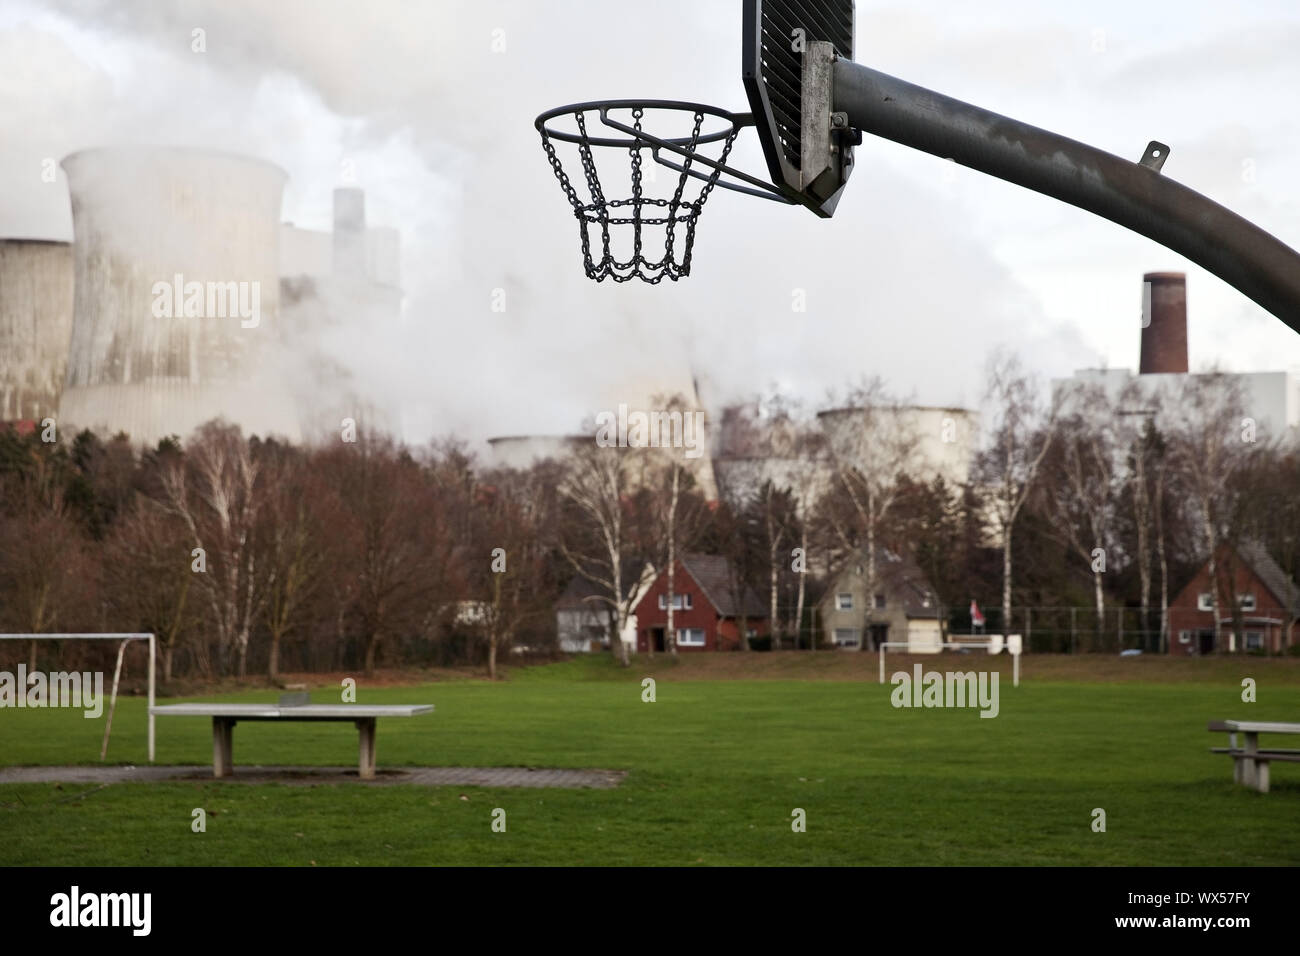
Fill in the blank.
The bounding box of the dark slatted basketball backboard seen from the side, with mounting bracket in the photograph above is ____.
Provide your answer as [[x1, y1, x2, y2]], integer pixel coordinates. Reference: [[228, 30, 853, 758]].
[[741, 0, 854, 217]]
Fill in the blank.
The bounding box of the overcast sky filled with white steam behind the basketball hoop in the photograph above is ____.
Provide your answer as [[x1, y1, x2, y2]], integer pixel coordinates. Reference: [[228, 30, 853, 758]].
[[0, 0, 1300, 442]]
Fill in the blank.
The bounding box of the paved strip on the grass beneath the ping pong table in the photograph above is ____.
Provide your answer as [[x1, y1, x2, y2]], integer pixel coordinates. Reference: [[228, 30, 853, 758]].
[[0, 766, 628, 790]]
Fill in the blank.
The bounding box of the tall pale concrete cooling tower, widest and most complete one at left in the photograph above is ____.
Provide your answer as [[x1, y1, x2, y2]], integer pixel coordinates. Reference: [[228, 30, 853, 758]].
[[60, 148, 299, 445]]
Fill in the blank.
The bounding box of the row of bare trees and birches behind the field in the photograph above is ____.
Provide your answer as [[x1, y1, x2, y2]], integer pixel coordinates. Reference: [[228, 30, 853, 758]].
[[0, 355, 1300, 682]]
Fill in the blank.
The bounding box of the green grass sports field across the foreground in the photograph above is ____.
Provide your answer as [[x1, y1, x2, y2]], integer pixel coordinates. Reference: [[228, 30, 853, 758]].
[[0, 654, 1300, 866]]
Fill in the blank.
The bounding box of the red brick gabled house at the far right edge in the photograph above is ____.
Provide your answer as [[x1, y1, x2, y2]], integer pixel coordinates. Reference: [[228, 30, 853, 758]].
[[1169, 542, 1300, 657]]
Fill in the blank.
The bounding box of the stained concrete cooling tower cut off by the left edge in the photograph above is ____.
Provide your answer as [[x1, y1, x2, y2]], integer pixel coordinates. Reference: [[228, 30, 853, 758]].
[[0, 239, 73, 421]]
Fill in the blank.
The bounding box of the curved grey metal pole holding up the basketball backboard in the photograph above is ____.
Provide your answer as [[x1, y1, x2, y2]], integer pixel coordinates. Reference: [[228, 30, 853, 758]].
[[833, 59, 1300, 332]]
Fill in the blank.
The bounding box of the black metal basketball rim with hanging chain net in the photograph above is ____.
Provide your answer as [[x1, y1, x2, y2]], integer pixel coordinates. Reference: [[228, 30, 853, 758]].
[[536, 100, 793, 285]]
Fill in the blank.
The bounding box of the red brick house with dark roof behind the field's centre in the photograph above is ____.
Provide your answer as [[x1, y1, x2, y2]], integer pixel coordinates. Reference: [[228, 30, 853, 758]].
[[634, 554, 767, 653]]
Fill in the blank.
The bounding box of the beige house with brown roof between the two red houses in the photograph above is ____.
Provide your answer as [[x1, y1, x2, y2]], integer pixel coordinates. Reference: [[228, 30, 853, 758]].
[[818, 548, 944, 654]]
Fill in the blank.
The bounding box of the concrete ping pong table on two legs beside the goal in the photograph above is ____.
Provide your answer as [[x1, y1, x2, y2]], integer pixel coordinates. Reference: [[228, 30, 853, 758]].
[[150, 704, 433, 780]]
